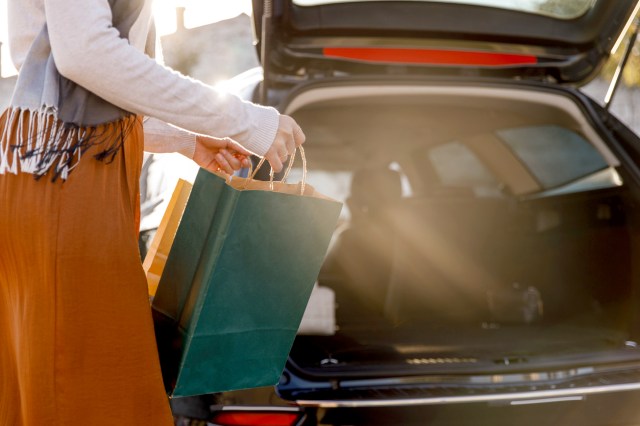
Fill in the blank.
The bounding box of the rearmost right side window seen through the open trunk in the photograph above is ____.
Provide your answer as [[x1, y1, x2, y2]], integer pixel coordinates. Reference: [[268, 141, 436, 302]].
[[497, 126, 608, 189]]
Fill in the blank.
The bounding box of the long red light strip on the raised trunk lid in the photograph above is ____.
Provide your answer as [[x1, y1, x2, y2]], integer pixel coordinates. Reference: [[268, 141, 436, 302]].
[[322, 47, 538, 67]]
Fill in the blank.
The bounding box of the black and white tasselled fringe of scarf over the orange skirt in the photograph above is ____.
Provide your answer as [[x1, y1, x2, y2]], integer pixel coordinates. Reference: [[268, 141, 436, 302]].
[[0, 108, 135, 182]]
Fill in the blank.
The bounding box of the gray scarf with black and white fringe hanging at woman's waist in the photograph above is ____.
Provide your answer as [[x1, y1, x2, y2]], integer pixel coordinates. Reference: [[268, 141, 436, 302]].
[[0, 0, 149, 181]]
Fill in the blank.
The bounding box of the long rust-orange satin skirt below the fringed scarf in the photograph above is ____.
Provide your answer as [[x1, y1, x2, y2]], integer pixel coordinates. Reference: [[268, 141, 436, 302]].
[[0, 113, 173, 426]]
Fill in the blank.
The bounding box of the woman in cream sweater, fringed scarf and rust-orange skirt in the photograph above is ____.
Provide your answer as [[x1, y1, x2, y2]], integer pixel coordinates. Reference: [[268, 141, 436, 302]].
[[0, 0, 304, 426]]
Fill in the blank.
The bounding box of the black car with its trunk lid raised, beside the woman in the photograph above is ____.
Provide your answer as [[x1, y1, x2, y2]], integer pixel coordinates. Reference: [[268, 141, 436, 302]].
[[174, 0, 640, 425]]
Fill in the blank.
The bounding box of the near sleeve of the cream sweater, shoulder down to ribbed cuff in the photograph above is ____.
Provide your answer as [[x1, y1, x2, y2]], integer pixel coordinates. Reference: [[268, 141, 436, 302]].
[[45, 0, 278, 155]]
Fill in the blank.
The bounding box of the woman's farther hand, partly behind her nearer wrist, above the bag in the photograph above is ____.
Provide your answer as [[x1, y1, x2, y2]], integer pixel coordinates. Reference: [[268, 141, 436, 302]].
[[193, 135, 251, 174]]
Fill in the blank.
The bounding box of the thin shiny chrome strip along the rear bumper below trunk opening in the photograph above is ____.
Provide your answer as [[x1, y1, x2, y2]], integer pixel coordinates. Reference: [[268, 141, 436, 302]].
[[296, 383, 640, 408]]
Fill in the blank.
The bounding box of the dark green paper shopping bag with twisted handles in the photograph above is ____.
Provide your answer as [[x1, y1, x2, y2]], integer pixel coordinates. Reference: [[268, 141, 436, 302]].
[[152, 151, 341, 397]]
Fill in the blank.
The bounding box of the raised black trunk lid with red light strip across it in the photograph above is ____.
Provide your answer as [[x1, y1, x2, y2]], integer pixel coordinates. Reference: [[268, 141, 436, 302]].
[[253, 0, 638, 84]]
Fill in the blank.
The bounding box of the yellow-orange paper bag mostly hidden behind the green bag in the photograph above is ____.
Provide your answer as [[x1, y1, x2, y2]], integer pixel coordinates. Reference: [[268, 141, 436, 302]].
[[142, 179, 192, 297]]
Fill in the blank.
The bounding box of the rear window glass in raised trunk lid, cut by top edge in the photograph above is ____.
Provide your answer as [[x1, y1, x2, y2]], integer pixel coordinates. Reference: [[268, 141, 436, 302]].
[[293, 0, 595, 19]]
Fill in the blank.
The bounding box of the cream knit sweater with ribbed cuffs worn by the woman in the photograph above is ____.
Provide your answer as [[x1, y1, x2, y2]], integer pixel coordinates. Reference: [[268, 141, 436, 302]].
[[8, 0, 278, 157]]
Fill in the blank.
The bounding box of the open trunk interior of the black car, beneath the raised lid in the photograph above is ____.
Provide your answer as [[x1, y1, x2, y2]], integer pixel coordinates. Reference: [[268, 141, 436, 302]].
[[279, 81, 640, 402]]
